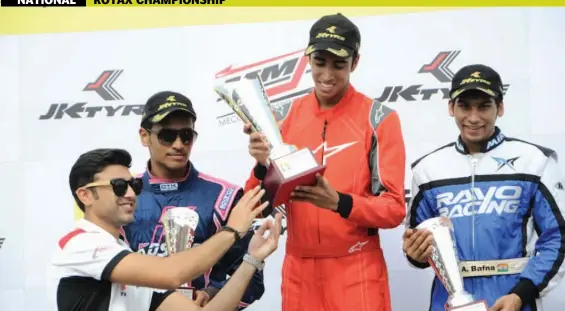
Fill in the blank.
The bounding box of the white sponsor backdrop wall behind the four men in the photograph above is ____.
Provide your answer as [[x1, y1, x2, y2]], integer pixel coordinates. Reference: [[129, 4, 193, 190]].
[[0, 8, 565, 311]]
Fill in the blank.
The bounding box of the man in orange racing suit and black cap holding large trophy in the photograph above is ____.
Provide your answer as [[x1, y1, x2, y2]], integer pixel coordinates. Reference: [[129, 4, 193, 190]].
[[244, 14, 406, 311]]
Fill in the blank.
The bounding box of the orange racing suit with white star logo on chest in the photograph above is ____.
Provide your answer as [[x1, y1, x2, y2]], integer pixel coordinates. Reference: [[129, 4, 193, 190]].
[[245, 85, 406, 311]]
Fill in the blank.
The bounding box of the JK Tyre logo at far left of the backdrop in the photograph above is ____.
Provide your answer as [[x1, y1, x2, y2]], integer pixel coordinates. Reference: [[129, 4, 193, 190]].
[[39, 69, 143, 120]]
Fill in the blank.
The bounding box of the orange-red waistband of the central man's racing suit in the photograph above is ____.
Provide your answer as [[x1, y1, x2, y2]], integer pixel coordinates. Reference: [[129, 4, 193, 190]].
[[286, 236, 381, 258]]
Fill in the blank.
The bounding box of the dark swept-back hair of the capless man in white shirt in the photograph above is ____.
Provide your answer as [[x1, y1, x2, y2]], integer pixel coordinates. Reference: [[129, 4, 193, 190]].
[[69, 149, 131, 212]]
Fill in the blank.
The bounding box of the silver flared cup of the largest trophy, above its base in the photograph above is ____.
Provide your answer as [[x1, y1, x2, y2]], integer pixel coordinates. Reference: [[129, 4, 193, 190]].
[[214, 77, 297, 159]]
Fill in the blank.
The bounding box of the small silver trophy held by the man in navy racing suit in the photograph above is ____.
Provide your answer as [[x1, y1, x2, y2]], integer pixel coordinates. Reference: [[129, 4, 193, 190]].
[[161, 207, 199, 300]]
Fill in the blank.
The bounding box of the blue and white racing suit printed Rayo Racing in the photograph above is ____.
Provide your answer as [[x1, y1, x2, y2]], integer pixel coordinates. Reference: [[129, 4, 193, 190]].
[[406, 128, 565, 311]]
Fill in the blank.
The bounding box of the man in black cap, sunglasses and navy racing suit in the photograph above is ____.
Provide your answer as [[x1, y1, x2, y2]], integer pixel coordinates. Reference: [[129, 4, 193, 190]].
[[120, 91, 264, 310]]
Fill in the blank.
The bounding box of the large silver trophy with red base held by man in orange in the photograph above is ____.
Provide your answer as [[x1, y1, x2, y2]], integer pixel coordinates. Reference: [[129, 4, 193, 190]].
[[214, 77, 326, 206]]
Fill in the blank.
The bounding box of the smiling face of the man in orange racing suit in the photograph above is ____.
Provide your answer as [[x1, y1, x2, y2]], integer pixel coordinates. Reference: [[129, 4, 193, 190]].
[[310, 51, 359, 103]]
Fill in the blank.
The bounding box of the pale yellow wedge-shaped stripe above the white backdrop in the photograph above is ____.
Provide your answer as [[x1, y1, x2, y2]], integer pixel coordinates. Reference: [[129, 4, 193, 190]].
[[0, 6, 453, 35]]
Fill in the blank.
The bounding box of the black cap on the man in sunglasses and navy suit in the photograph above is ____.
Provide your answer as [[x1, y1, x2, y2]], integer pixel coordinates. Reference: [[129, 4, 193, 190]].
[[141, 91, 196, 125]]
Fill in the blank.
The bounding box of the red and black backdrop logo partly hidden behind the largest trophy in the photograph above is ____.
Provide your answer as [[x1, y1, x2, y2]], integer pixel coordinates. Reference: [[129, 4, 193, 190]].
[[216, 50, 312, 127]]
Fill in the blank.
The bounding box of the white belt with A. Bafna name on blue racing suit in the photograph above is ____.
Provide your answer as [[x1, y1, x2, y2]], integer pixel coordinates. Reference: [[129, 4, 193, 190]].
[[459, 257, 530, 278]]
